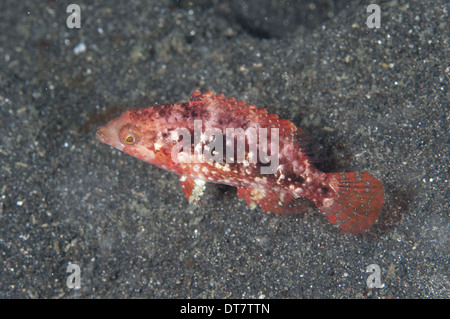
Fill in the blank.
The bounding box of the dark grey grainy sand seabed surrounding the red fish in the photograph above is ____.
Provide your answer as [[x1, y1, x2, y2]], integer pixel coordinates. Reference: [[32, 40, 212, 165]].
[[0, 0, 449, 298]]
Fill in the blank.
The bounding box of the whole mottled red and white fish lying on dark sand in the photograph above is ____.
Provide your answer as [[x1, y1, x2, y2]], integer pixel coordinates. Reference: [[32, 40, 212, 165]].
[[96, 90, 385, 235]]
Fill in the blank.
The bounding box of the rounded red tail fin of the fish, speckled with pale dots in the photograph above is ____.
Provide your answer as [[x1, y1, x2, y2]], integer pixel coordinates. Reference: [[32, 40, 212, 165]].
[[320, 173, 384, 235]]
